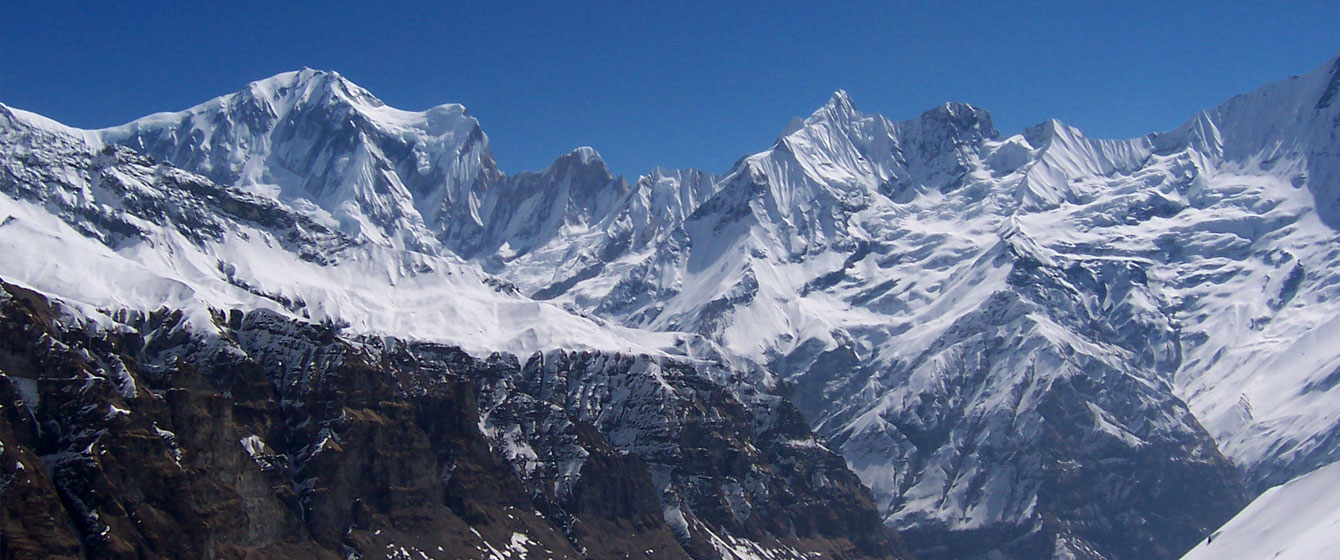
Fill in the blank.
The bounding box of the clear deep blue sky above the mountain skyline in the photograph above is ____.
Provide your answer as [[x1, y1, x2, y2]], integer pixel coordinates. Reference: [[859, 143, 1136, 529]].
[[0, 0, 1340, 176]]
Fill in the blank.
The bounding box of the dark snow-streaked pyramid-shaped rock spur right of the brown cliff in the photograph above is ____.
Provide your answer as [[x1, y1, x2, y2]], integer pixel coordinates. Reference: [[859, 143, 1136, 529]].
[[792, 245, 1245, 559]]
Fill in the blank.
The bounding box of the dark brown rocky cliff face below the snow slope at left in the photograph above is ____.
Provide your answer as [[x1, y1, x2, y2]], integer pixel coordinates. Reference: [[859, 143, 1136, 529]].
[[0, 284, 899, 559]]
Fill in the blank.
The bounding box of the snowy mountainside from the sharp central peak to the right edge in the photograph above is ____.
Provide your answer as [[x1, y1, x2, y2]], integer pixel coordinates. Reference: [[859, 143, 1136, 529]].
[[487, 55, 1340, 557]]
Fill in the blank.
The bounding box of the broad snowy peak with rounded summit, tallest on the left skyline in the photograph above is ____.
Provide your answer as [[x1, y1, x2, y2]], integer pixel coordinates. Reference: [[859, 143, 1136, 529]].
[[96, 68, 493, 251]]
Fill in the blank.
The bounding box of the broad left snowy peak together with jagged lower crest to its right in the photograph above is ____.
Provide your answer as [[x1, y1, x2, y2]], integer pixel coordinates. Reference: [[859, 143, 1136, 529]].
[[83, 68, 728, 270]]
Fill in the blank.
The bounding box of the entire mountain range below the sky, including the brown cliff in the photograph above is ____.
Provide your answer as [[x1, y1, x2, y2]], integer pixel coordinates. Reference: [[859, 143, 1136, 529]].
[[0, 52, 1340, 560]]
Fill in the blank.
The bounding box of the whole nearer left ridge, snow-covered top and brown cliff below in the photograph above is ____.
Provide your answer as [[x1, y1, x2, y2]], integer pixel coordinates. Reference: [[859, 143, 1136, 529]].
[[0, 106, 902, 560]]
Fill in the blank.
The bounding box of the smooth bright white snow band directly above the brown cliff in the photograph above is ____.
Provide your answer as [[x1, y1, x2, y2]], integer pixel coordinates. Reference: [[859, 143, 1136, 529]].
[[0, 159, 673, 355]]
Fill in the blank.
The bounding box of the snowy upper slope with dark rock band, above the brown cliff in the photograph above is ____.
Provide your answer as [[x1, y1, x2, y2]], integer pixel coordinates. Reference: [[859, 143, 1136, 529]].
[[0, 102, 673, 355]]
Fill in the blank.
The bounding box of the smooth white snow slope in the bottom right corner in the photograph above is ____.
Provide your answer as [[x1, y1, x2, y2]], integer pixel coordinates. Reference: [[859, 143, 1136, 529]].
[[1182, 464, 1340, 560]]
